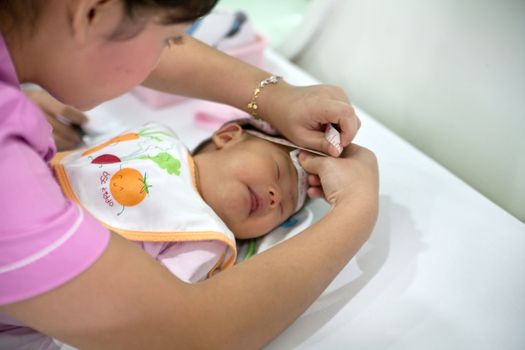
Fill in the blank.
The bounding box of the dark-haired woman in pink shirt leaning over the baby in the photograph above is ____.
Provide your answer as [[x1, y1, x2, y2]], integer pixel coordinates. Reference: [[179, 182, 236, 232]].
[[0, 0, 378, 349]]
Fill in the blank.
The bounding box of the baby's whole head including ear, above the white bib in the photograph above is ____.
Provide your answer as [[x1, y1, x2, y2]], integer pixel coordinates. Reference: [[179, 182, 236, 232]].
[[194, 123, 306, 239]]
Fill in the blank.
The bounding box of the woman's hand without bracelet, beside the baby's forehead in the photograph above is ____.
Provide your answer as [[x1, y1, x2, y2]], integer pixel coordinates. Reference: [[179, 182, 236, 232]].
[[299, 144, 379, 207]]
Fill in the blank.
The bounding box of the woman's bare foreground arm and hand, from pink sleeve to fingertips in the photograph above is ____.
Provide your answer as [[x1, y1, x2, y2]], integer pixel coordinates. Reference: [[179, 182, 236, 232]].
[[1, 149, 378, 349]]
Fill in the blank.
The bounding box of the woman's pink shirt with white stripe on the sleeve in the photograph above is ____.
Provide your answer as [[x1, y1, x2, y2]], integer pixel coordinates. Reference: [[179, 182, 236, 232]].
[[0, 35, 109, 306]]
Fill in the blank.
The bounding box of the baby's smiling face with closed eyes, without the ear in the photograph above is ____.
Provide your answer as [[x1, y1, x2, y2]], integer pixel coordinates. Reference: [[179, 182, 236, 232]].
[[205, 136, 298, 239]]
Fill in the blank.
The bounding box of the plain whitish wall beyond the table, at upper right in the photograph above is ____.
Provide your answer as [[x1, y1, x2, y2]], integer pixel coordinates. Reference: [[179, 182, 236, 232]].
[[297, 0, 525, 221]]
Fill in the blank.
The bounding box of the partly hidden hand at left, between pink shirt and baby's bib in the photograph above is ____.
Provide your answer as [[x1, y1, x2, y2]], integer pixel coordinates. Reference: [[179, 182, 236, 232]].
[[25, 90, 87, 151]]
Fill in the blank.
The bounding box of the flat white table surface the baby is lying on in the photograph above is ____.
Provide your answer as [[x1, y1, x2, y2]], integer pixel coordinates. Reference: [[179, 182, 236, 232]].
[[90, 51, 525, 350]]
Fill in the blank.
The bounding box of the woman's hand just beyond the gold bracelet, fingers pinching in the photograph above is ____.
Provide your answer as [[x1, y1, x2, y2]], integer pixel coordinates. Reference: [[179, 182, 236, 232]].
[[260, 81, 361, 157]]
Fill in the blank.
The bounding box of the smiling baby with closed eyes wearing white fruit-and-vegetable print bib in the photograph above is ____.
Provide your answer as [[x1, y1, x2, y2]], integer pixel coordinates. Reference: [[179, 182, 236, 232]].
[[52, 119, 316, 282]]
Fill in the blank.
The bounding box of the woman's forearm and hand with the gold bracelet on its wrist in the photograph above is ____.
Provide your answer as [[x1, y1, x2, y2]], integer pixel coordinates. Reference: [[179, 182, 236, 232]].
[[143, 37, 361, 156]]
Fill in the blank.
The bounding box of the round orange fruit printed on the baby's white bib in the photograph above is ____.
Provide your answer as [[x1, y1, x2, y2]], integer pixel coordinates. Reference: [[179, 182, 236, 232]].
[[109, 168, 151, 207]]
